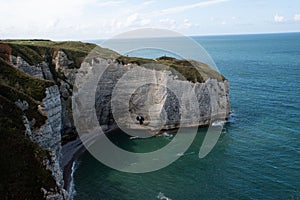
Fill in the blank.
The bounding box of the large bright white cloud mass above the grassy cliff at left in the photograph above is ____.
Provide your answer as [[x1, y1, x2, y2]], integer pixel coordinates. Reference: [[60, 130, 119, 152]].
[[0, 0, 95, 38]]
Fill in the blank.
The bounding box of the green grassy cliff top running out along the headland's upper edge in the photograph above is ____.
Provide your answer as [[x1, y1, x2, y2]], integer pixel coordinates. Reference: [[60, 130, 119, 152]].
[[0, 40, 226, 83]]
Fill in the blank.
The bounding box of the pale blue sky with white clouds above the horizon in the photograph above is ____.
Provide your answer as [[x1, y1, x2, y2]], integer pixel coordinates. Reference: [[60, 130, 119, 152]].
[[0, 0, 300, 40]]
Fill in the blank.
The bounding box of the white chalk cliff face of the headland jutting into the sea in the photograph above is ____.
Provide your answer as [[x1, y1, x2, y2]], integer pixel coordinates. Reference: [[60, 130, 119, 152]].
[[76, 59, 230, 134]]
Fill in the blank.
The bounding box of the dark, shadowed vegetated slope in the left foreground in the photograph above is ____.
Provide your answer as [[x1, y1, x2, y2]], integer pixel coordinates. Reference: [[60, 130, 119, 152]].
[[0, 58, 56, 199]]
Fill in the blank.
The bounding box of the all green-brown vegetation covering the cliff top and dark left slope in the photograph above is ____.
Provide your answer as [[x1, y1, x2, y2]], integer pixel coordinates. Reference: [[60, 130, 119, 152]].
[[0, 40, 225, 199]]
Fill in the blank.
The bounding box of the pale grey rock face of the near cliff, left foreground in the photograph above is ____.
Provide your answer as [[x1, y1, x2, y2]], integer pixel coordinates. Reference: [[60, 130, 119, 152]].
[[23, 85, 67, 199]]
